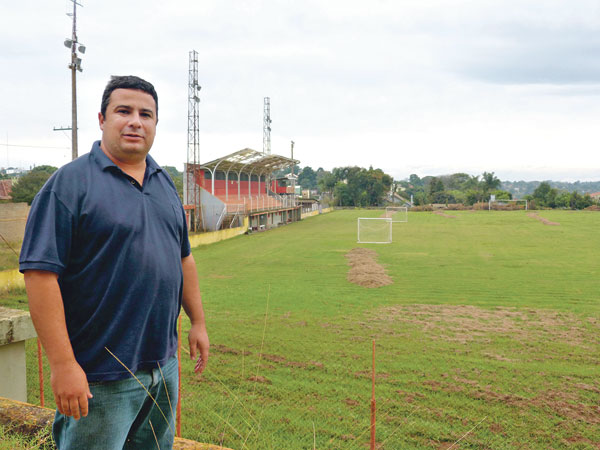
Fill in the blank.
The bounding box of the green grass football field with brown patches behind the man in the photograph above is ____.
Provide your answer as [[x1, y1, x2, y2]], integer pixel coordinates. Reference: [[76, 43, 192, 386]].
[[5, 211, 600, 449]]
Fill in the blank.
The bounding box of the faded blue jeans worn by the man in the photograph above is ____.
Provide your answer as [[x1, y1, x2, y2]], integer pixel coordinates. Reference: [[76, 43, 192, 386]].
[[52, 357, 179, 450]]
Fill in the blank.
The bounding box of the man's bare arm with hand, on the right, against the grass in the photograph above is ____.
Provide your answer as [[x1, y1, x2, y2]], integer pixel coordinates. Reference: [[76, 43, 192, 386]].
[[181, 253, 210, 375]]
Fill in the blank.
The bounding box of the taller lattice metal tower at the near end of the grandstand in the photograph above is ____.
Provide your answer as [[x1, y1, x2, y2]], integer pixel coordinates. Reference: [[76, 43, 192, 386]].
[[185, 50, 201, 231]]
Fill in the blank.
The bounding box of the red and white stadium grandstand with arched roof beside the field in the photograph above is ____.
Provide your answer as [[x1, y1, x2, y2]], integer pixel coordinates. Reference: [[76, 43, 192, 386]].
[[183, 148, 301, 231]]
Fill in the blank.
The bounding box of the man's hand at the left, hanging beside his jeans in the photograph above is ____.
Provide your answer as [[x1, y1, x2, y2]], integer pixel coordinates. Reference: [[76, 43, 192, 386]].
[[50, 362, 93, 420]]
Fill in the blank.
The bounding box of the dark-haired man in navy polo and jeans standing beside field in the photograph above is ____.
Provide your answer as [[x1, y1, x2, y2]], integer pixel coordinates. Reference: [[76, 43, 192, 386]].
[[20, 76, 209, 450]]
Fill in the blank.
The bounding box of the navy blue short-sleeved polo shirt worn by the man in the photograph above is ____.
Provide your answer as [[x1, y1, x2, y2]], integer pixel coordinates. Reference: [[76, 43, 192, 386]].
[[19, 141, 190, 381]]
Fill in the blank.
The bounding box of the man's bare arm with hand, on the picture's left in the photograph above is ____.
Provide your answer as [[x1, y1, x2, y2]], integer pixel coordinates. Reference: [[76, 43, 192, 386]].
[[25, 270, 92, 419]]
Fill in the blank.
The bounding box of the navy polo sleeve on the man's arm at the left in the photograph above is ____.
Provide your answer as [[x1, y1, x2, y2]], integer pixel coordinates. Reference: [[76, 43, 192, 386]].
[[19, 190, 75, 275]]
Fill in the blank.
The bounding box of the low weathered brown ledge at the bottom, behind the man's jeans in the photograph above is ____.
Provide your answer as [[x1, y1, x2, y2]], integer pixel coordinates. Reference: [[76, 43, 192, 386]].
[[0, 397, 231, 450]]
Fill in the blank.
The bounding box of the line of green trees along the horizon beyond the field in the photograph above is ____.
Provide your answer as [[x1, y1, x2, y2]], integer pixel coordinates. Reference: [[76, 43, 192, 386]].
[[11, 165, 597, 209]]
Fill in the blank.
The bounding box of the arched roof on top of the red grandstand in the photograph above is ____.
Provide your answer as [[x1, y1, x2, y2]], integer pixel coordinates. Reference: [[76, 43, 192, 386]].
[[200, 148, 300, 174]]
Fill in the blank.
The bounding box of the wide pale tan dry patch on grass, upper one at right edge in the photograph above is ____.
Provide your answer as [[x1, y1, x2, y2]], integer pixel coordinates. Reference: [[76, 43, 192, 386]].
[[367, 305, 600, 348]]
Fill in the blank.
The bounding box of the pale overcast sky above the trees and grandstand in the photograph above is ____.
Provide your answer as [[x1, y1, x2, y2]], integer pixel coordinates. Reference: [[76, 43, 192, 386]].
[[0, 0, 600, 181]]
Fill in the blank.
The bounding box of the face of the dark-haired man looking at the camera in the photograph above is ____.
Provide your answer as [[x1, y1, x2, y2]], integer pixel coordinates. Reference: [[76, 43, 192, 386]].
[[98, 89, 157, 164]]
